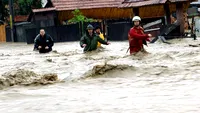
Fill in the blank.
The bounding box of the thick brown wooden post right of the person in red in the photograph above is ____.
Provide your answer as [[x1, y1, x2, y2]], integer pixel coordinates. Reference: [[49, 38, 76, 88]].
[[176, 3, 184, 35]]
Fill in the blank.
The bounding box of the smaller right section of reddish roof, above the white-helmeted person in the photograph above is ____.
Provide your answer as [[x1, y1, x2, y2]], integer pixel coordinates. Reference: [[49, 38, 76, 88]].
[[119, 0, 195, 8]]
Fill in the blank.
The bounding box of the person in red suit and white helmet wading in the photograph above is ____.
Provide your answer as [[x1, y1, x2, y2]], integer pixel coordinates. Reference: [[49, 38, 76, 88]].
[[128, 16, 152, 55]]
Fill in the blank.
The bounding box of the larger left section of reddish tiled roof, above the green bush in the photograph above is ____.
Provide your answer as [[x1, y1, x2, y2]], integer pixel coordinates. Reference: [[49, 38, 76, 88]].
[[51, 0, 124, 11]]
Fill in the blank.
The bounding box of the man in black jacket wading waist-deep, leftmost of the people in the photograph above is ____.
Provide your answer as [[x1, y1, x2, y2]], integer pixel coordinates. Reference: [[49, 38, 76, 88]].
[[34, 29, 54, 53]]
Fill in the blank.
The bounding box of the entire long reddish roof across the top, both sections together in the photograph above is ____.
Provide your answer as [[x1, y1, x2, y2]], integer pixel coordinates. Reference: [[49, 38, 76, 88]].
[[33, 0, 195, 12]]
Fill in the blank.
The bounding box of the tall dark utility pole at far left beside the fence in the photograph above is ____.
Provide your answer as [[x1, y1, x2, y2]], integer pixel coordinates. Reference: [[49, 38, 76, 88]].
[[9, 0, 14, 42]]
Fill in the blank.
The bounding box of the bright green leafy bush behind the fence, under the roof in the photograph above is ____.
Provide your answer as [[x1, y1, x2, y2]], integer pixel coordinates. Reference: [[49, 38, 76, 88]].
[[68, 9, 94, 23]]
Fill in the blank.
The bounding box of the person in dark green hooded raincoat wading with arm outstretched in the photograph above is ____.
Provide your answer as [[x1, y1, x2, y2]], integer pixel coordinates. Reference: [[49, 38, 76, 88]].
[[80, 24, 110, 52]]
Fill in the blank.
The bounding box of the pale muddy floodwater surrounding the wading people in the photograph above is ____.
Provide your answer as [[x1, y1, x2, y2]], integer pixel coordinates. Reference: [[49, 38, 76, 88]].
[[0, 39, 200, 113]]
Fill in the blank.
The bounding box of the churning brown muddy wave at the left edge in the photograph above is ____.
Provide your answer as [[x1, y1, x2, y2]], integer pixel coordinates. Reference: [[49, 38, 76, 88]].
[[0, 69, 58, 89]]
